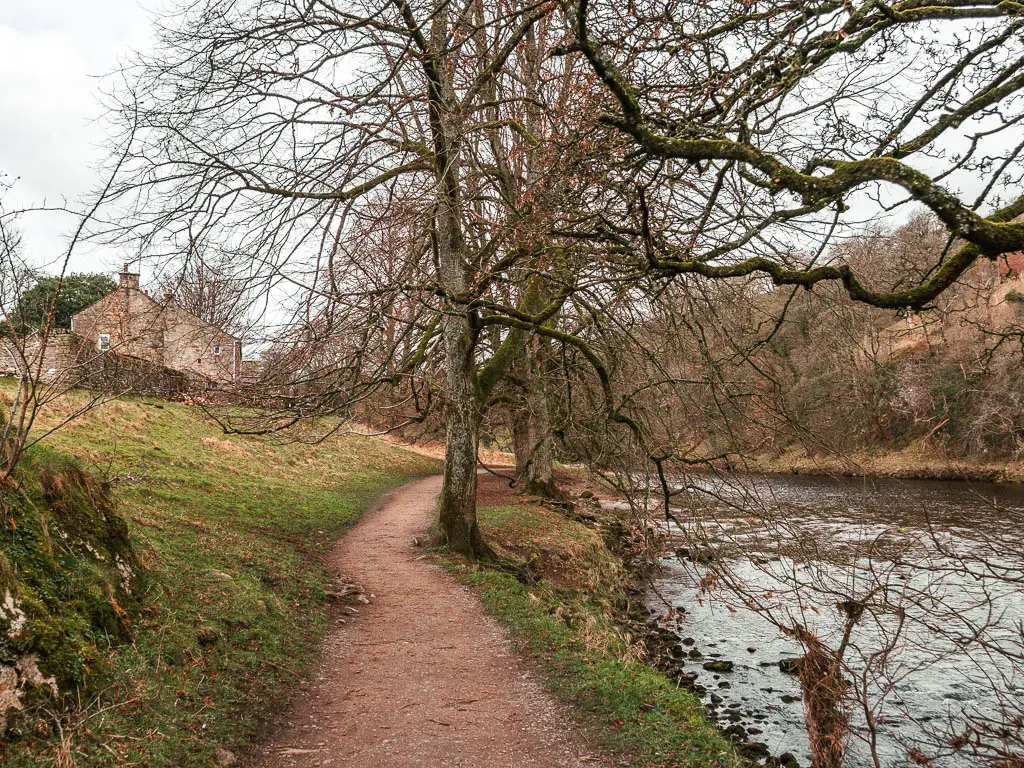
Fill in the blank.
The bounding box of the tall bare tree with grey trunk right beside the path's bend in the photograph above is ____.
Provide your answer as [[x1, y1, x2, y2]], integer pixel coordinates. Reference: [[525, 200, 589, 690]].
[[103, 0, 618, 556]]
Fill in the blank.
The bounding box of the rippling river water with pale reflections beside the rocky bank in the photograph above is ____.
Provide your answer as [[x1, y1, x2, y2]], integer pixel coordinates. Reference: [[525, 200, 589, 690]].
[[648, 475, 1024, 768]]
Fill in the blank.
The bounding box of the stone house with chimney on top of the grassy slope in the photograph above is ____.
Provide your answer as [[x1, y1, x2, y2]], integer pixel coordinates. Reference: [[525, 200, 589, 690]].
[[72, 265, 243, 384]]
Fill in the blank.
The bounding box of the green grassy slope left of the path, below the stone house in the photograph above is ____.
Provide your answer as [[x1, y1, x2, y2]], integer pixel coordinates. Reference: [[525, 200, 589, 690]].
[[0, 399, 438, 768]]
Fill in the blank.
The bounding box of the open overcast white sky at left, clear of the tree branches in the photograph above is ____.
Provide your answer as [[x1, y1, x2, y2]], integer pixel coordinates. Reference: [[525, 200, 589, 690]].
[[0, 0, 154, 271]]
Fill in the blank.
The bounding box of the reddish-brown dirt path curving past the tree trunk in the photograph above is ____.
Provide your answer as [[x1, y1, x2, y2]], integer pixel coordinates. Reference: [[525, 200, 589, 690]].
[[256, 477, 604, 768]]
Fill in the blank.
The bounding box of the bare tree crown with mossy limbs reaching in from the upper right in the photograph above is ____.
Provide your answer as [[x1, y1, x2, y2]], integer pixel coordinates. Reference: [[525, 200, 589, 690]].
[[563, 0, 1024, 309]]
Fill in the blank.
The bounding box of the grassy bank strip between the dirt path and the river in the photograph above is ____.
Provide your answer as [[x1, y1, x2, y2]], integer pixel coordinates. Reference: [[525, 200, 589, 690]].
[[444, 483, 742, 768]]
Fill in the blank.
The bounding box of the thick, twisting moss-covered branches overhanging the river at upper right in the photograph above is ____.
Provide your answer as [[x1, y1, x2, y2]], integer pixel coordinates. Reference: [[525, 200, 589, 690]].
[[562, 0, 1024, 308]]
